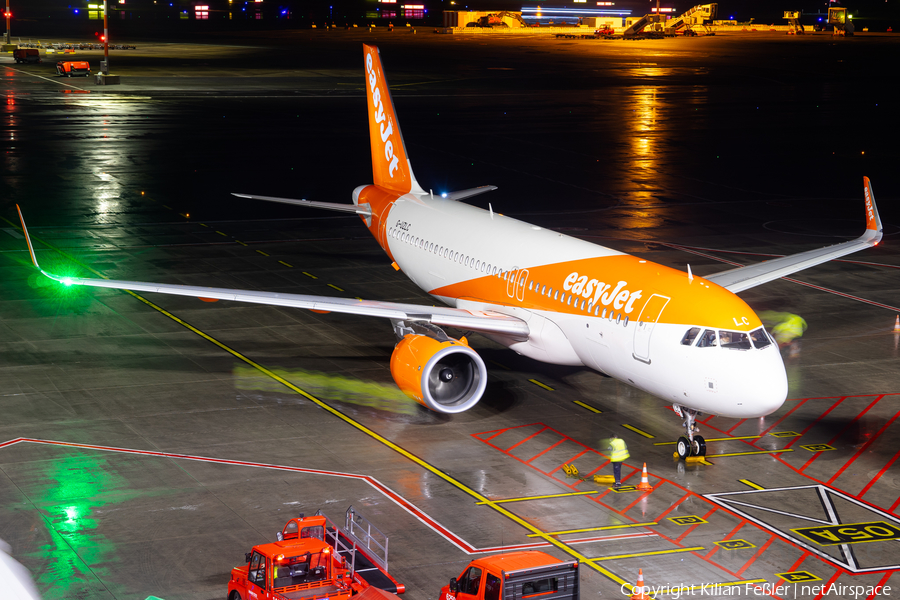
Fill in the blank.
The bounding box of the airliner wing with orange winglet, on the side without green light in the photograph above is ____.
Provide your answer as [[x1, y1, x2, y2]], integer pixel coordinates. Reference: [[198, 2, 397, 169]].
[[704, 177, 884, 293]]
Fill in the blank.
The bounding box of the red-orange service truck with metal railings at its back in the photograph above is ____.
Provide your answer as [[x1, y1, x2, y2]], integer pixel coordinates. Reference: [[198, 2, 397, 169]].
[[228, 506, 406, 600]]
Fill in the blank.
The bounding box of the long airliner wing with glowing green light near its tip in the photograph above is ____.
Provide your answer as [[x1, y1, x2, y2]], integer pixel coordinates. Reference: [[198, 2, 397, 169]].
[[16, 205, 529, 337]]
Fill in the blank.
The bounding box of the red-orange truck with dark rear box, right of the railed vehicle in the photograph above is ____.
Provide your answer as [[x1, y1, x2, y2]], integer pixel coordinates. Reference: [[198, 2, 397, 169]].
[[438, 550, 581, 600]]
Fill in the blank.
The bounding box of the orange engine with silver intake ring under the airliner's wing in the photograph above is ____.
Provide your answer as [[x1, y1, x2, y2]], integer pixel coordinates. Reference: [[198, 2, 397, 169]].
[[391, 333, 487, 413]]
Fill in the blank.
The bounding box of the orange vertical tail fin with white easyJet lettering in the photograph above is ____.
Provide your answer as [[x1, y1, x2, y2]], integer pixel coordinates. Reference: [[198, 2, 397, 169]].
[[363, 44, 424, 194]]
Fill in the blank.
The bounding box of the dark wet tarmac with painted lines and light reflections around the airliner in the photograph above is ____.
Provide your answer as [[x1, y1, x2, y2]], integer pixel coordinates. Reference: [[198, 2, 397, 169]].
[[0, 30, 900, 600]]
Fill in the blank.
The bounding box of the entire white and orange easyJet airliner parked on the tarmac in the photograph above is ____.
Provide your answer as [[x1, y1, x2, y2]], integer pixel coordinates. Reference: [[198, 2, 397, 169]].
[[20, 45, 882, 457]]
